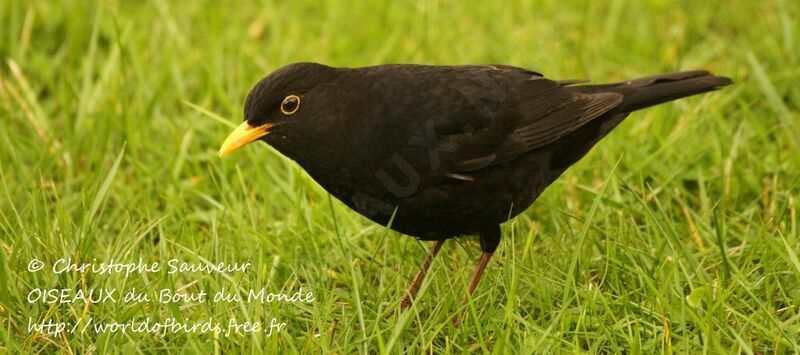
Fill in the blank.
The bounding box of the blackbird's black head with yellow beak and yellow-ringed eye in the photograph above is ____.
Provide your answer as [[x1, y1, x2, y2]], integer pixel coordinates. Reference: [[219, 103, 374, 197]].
[[219, 63, 337, 156]]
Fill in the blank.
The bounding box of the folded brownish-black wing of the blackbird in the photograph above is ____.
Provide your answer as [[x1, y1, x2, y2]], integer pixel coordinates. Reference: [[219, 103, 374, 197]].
[[440, 72, 623, 174]]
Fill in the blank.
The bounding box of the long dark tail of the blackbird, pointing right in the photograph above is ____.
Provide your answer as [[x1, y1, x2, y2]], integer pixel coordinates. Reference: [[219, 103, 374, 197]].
[[573, 70, 731, 113]]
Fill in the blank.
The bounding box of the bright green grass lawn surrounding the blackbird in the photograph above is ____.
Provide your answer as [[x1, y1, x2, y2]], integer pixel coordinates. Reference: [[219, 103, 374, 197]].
[[0, 0, 800, 354]]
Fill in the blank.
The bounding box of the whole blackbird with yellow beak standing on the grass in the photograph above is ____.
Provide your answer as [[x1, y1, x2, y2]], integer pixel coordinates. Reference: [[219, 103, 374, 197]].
[[219, 63, 731, 309]]
